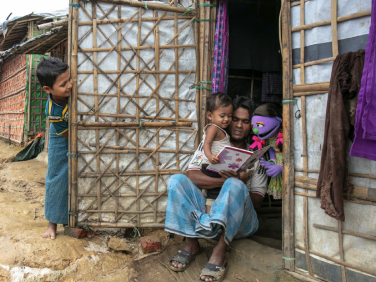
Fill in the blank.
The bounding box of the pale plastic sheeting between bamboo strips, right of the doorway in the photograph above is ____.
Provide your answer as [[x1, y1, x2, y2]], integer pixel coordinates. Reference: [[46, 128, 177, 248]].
[[291, 0, 376, 276]]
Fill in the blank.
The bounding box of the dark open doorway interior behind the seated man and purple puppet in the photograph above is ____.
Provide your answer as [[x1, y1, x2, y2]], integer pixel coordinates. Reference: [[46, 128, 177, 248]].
[[228, 0, 282, 240]]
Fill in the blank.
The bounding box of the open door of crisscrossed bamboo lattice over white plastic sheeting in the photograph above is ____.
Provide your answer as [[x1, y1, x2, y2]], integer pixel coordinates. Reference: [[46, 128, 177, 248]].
[[68, 0, 200, 227]]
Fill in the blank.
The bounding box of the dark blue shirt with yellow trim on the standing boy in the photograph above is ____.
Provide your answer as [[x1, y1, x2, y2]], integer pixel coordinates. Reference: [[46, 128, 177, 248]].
[[46, 95, 68, 135]]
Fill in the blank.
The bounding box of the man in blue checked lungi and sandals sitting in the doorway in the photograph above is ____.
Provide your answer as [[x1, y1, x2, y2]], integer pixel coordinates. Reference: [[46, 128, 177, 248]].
[[165, 97, 268, 281]]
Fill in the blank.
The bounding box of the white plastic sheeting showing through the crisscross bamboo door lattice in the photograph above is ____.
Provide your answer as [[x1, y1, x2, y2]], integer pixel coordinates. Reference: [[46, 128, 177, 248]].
[[73, 2, 197, 223]]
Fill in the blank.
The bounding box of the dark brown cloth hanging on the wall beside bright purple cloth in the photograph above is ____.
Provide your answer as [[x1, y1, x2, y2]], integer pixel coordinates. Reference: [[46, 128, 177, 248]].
[[316, 50, 364, 221]]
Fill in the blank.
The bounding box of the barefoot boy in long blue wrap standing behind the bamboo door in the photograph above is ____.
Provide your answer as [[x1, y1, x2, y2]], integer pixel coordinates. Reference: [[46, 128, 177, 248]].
[[37, 57, 72, 239]]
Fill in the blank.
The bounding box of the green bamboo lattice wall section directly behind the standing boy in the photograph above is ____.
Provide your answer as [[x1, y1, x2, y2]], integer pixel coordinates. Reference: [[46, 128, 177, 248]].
[[25, 22, 48, 138]]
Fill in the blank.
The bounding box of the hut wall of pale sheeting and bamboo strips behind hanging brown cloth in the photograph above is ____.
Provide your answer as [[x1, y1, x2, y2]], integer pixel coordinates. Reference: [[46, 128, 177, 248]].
[[285, 0, 376, 281]]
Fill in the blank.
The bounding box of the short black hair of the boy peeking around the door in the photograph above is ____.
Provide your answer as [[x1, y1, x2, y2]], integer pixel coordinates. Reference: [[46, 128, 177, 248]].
[[37, 57, 69, 88]]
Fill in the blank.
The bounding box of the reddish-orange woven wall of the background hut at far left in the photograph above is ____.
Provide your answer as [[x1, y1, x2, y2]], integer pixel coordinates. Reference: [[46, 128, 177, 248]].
[[0, 55, 27, 144]]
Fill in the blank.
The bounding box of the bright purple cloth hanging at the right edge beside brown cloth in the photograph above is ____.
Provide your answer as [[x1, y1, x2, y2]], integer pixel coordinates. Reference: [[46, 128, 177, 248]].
[[350, 0, 376, 161]]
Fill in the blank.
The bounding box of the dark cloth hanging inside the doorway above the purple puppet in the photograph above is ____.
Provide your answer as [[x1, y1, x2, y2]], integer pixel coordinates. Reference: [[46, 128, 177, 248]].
[[261, 72, 282, 104]]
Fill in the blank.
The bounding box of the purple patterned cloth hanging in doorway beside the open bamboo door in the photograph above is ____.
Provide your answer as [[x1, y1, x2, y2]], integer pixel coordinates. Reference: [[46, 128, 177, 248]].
[[212, 0, 229, 93]]
